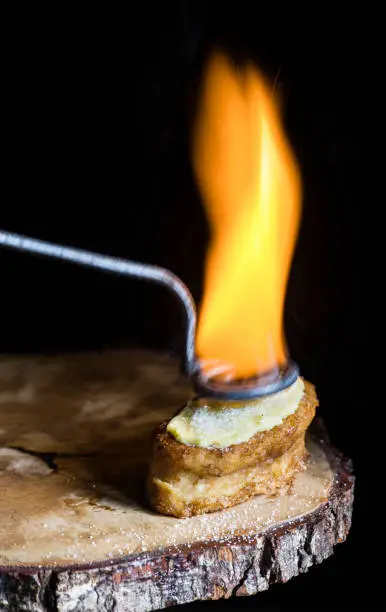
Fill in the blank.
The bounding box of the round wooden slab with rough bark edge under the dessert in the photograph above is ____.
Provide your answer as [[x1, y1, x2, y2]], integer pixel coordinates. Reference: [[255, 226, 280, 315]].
[[0, 351, 354, 612]]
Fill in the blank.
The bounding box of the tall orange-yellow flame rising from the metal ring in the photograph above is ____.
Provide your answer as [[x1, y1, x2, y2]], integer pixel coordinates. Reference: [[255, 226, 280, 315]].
[[193, 54, 302, 380]]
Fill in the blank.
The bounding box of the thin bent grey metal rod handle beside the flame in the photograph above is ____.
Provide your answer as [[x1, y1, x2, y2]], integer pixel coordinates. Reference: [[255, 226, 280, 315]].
[[0, 230, 197, 375]]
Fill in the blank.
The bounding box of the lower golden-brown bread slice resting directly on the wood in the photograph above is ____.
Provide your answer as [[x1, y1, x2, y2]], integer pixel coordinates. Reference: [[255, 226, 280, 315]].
[[148, 434, 306, 517]]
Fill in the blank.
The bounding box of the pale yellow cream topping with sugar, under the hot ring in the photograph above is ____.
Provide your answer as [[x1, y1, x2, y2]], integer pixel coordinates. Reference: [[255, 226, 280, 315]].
[[167, 377, 304, 448]]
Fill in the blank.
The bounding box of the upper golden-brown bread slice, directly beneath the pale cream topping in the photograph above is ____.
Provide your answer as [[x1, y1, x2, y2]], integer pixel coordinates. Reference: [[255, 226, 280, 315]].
[[151, 381, 318, 480]]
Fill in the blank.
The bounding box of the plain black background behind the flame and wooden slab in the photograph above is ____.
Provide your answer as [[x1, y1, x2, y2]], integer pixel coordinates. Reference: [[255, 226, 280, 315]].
[[0, 1, 384, 611]]
